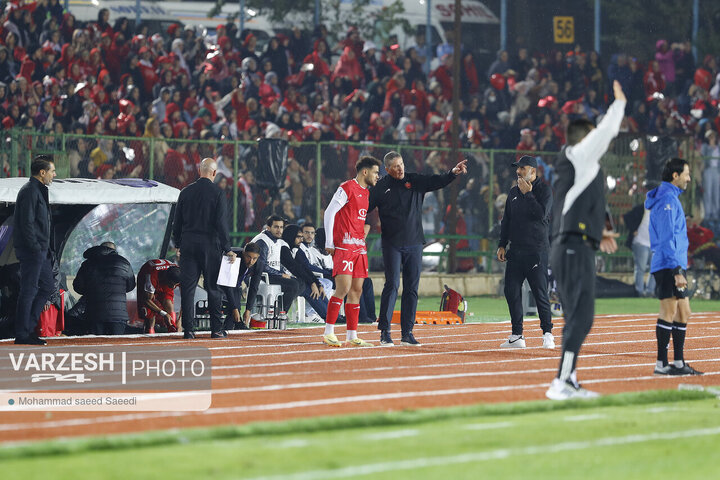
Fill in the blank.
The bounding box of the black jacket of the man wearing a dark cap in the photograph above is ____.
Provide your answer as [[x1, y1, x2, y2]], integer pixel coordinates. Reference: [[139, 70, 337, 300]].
[[498, 178, 552, 253]]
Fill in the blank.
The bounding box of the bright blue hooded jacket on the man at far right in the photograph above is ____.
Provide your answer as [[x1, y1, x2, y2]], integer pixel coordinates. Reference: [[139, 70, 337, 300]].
[[645, 182, 689, 272]]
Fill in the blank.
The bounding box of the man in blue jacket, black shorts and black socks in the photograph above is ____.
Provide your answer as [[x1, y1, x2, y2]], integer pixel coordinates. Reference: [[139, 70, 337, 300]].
[[645, 158, 702, 375]]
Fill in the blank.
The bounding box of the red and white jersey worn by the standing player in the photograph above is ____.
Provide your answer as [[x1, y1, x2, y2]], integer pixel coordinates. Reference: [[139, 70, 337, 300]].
[[323, 179, 370, 253]]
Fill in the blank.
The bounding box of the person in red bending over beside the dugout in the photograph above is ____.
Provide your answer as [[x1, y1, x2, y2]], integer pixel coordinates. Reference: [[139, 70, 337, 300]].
[[137, 259, 180, 333]]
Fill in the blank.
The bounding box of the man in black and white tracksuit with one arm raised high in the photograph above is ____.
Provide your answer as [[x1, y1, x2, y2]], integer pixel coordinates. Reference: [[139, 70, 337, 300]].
[[545, 81, 627, 400]]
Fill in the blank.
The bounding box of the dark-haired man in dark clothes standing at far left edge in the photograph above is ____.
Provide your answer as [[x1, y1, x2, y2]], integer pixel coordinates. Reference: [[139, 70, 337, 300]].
[[13, 155, 55, 345]]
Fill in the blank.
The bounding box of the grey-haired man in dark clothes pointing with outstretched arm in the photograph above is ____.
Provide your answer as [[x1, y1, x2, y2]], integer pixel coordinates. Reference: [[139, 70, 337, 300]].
[[368, 152, 467, 346]]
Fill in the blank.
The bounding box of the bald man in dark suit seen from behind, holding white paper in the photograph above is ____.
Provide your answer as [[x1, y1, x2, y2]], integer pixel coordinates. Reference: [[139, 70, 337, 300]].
[[173, 158, 237, 339]]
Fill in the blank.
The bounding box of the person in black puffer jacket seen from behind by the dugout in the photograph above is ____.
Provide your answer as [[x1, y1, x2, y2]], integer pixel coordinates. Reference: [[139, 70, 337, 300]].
[[73, 242, 135, 335]]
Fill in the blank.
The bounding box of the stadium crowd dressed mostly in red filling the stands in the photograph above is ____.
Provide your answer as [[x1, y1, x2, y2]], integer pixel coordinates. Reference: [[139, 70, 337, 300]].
[[0, 0, 720, 233]]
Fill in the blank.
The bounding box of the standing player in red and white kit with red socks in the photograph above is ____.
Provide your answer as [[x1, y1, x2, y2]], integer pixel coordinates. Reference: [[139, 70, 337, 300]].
[[323, 156, 380, 347]]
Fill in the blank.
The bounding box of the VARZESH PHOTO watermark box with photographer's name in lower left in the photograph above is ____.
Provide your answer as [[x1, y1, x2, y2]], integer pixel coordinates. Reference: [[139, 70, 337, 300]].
[[0, 345, 212, 411]]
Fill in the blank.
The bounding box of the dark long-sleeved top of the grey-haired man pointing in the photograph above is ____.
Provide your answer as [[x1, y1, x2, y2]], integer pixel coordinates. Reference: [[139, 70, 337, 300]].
[[368, 172, 457, 247]]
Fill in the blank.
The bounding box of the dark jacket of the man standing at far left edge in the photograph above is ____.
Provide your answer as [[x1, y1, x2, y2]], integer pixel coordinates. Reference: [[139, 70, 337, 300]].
[[13, 177, 51, 252]]
